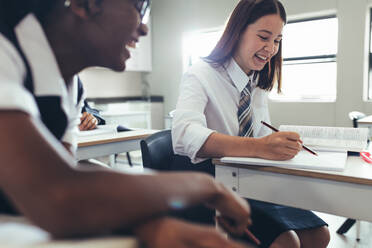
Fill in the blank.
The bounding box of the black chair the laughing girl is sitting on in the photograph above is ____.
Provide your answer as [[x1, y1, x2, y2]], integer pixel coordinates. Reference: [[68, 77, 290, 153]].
[[141, 129, 215, 225]]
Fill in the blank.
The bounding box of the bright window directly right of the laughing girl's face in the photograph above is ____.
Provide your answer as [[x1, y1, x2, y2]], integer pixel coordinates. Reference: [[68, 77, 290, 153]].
[[270, 16, 338, 102]]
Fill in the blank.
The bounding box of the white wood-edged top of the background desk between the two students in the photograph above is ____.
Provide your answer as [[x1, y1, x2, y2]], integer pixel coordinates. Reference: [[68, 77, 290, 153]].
[[78, 129, 158, 147]]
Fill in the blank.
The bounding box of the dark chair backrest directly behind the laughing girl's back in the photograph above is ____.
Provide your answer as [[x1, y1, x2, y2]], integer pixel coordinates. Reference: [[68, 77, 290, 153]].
[[141, 129, 174, 170]]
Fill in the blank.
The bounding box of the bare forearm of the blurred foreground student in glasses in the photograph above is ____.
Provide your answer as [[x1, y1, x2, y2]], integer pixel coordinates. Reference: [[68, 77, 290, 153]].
[[10, 171, 219, 236]]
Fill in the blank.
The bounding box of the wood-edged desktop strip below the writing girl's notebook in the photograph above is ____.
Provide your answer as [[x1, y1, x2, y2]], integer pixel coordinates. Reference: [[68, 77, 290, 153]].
[[212, 156, 372, 186]]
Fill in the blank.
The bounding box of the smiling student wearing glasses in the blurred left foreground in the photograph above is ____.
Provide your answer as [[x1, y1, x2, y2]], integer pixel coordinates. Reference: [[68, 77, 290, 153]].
[[0, 0, 250, 248]]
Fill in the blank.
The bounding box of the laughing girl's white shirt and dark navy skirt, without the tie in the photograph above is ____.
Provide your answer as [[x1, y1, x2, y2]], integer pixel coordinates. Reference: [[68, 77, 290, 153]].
[[172, 59, 326, 247]]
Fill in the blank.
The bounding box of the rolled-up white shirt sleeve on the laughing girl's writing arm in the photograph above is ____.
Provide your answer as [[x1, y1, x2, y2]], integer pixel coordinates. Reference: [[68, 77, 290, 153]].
[[172, 73, 214, 163]]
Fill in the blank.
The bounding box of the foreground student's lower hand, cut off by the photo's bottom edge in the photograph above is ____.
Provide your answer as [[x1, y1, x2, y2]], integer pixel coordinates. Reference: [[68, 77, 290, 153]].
[[136, 218, 245, 248]]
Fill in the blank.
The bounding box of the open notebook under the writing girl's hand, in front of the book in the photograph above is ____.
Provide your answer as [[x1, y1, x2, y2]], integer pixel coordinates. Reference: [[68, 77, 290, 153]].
[[221, 151, 347, 171]]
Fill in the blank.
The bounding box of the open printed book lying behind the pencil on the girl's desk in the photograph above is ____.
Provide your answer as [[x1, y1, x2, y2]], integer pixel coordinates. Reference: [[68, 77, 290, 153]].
[[279, 125, 369, 152]]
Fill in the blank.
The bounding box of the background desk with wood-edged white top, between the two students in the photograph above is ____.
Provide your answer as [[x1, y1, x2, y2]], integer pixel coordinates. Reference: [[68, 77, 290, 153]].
[[76, 130, 157, 160]]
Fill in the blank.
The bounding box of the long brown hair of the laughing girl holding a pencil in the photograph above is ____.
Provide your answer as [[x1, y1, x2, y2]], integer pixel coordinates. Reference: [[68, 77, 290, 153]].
[[204, 0, 287, 92]]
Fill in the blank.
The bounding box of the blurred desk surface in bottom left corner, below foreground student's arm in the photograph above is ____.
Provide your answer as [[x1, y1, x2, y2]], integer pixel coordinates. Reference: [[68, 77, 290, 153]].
[[0, 215, 139, 248]]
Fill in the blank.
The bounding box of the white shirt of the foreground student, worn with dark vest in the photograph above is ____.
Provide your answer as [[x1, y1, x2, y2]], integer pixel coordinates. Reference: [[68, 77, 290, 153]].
[[0, 14, 79, 149]]
